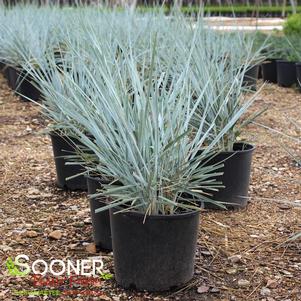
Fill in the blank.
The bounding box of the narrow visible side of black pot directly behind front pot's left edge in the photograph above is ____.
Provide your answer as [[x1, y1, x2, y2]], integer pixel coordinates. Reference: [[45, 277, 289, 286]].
[[86, 176, 112, 251]]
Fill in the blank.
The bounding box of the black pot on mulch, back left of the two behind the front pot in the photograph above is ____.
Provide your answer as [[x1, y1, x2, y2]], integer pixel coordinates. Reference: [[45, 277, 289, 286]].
[[50, 132, 87, 190]]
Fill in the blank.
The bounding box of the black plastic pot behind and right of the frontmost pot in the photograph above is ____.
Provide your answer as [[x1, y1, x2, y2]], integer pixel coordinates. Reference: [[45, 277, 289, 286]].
[[204, 143, 255, 209]]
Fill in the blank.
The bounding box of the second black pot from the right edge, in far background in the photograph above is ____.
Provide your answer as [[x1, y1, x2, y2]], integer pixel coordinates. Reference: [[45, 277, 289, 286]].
[[277, 60, 297, 87]]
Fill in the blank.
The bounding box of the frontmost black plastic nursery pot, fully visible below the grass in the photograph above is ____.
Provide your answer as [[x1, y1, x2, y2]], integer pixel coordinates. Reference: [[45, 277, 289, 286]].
[[110, 209, 199, 291]]
